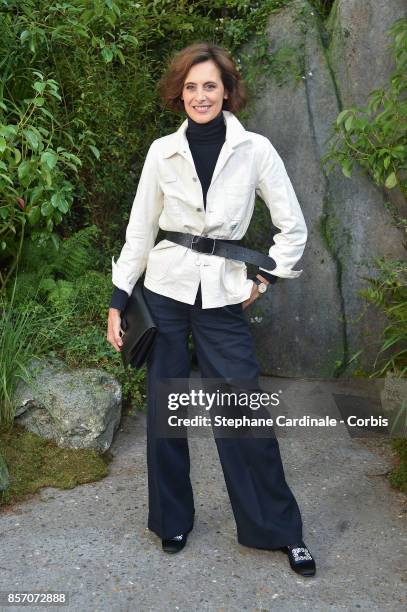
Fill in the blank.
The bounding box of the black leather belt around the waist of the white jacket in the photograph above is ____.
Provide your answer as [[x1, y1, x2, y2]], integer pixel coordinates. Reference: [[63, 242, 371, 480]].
[[165, 232, 277, 272]]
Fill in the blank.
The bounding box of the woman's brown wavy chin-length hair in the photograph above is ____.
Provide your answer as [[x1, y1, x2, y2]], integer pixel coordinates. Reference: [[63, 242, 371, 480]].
[[157, 42, 247, 113]]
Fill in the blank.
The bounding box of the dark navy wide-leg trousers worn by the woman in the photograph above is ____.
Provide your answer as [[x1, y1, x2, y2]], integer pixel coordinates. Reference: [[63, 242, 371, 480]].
[[144, 287, 302, 549]]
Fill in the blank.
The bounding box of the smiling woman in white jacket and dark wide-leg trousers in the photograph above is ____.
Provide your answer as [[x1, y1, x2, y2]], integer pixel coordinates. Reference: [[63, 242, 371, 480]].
[[107, 43, 315, 575]]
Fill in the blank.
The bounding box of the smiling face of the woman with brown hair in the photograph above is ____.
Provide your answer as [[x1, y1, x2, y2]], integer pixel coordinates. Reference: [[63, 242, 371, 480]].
[[181, 60, 228, 123]]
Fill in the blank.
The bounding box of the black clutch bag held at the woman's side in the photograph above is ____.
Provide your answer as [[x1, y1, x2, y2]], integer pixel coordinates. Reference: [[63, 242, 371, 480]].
[[120, 279, 157, 369]]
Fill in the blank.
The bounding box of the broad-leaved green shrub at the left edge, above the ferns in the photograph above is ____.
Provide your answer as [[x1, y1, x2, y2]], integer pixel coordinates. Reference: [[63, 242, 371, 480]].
[[0, 65, 98, 286]]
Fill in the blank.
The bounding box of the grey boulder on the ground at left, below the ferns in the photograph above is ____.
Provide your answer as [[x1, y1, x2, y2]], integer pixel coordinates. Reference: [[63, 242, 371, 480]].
[[14, 358, 122, 451]]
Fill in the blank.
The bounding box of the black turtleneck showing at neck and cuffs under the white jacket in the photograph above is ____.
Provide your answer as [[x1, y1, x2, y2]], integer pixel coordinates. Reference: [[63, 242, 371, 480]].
[[110, 111, 279, 311]]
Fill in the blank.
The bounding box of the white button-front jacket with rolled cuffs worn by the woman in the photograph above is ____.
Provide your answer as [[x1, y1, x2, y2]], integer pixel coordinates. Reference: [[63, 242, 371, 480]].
[[112, 110, 307, 308]]
